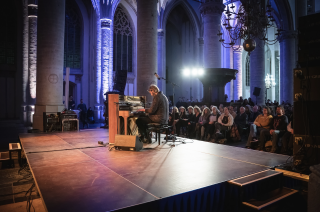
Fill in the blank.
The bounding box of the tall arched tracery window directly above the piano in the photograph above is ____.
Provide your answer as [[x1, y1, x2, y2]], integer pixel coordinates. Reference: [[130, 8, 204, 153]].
[[113, 7, 133, 72]]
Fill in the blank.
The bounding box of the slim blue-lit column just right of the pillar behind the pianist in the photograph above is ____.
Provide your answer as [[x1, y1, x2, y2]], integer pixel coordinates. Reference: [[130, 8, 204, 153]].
[[158, 29, 166, 93]]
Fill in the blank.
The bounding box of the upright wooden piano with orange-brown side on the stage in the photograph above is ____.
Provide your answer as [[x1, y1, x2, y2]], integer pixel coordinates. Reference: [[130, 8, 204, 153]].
[[108, 94, 146, 144]]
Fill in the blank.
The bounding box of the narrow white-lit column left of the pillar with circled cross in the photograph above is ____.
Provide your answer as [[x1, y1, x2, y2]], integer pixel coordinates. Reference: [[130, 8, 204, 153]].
[[28, 4, 38, 104]]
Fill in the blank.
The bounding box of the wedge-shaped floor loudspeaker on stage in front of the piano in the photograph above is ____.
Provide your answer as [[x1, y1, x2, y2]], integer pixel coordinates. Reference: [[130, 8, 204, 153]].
[[114, 135, 143, 151]]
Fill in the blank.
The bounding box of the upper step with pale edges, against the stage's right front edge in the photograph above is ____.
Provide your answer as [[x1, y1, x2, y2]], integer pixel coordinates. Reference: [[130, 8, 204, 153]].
[[228, 170, 282, 187]]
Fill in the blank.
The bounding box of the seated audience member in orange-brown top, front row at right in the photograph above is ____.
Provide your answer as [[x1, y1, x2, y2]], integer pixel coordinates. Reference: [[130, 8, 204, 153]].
[[246, 107, 273, 148]]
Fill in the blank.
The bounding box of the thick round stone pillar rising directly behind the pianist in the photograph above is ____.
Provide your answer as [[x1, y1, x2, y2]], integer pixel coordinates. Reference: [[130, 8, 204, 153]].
[[137, 0, 158, 102]]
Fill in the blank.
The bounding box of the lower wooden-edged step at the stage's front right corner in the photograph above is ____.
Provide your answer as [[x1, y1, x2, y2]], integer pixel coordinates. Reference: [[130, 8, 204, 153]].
[[242, 187, 298, 210]]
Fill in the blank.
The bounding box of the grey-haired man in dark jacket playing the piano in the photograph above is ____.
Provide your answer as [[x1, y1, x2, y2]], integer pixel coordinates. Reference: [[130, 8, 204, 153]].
[[136, 84, 169, 143]]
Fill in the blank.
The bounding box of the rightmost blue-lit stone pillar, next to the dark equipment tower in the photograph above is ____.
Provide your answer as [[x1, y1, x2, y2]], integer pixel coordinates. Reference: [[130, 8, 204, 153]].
[[280, 31, 296, 104]]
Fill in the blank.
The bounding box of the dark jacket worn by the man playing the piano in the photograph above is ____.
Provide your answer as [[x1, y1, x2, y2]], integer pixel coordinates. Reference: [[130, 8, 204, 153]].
[[146, 91, 169, 124]]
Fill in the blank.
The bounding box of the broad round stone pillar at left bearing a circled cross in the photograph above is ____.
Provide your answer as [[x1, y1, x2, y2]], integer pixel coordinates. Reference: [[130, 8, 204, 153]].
[[33, 0, 65, 131]]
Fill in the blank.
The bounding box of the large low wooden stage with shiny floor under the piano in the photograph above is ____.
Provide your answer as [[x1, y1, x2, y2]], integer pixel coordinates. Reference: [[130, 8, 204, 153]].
[[19, 129, 288, 212]]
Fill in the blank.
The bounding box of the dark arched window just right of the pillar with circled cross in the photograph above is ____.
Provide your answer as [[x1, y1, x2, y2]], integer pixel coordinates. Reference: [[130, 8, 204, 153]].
[[64, 0, 81, 69]]
